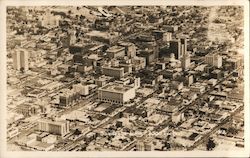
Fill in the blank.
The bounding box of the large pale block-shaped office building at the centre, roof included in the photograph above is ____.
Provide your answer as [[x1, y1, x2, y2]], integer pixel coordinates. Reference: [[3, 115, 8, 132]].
[[98, 83, 135, 104]]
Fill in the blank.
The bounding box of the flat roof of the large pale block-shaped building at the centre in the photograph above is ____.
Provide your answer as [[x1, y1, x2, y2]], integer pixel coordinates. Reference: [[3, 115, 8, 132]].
[[100, 83, 133, 93]]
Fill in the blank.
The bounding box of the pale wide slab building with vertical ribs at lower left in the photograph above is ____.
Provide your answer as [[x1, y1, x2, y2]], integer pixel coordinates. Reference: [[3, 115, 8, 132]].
[[38, 119, 69, 136]]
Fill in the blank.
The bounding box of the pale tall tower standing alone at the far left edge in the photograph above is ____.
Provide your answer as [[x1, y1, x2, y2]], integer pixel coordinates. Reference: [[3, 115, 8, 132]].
[[13, 50, 29, 71]]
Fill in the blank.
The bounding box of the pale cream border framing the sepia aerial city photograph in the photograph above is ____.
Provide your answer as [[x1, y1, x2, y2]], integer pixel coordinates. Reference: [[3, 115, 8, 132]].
[[0, 0, 250, 158]]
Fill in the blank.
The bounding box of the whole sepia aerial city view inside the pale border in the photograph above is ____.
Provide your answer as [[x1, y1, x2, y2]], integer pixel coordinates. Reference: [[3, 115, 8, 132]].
[[6, 5, 245, 152]]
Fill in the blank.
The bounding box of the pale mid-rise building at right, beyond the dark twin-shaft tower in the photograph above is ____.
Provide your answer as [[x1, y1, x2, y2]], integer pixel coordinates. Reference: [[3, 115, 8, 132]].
[[205, 53, 222, 68]]
